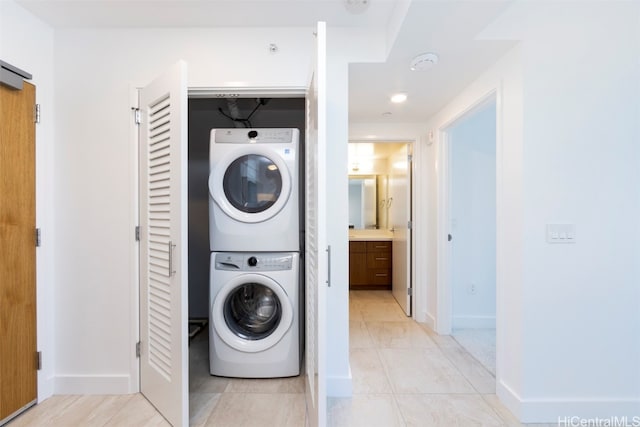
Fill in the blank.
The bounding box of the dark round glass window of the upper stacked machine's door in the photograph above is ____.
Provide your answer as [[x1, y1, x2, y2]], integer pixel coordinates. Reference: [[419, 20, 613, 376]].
[[222, 154, 282, 213]]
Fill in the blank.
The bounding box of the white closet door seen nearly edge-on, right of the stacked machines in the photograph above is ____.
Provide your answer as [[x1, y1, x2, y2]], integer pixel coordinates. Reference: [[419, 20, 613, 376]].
[[305, 22, 330, 427]]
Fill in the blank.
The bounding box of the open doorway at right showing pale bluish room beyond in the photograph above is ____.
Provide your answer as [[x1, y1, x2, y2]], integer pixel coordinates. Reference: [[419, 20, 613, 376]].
[[439, 96, 497, 376]]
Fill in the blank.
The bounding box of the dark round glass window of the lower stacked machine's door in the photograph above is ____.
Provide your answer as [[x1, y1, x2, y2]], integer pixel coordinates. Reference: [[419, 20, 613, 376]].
[[224, 283, 282, 340]]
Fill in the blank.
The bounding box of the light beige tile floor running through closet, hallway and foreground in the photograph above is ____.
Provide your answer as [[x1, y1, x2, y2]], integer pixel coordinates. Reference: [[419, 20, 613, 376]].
[[9, 291, 552, 427]]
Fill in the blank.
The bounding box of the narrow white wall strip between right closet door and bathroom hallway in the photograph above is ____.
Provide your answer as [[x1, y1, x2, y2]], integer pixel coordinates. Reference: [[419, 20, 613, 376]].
[[327, 28, 386, 396]]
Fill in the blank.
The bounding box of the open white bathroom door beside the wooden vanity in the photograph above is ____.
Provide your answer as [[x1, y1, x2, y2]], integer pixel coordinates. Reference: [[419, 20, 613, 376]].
[[389, 144, 412, 316]]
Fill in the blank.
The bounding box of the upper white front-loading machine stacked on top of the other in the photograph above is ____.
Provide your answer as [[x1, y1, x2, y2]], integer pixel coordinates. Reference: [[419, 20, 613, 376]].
[[209, 128, 300, 252]]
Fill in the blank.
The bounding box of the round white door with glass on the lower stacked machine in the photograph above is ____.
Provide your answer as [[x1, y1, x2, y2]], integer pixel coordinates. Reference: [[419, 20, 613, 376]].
[[211, 274, 293, 353]]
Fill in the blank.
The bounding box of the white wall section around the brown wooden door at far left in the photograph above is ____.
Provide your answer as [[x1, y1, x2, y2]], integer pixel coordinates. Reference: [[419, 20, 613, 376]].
[[0, 0, 56, 400]]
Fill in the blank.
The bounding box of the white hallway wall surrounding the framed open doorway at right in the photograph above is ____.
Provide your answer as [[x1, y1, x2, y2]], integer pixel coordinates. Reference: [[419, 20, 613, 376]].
[[419, 42, 523, 422]]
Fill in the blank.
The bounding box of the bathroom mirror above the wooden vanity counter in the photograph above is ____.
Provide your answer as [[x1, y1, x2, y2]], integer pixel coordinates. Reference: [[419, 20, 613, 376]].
[[349, 175, 389, 230]]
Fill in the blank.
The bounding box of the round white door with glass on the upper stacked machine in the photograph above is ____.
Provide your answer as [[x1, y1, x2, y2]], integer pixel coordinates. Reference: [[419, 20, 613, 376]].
[[209, 145, 291, 223]]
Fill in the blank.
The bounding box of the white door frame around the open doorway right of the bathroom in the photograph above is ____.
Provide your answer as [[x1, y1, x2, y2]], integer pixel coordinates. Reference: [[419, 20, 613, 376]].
[[435, 89, 502, 334]]
